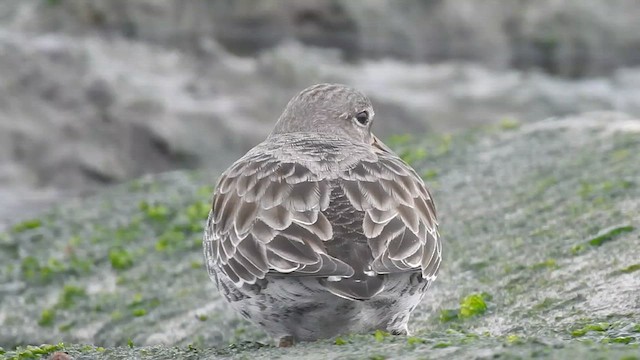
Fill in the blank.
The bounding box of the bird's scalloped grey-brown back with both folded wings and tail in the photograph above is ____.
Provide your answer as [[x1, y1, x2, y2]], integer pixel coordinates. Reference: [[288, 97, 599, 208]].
[[204, 84, 441, 299]]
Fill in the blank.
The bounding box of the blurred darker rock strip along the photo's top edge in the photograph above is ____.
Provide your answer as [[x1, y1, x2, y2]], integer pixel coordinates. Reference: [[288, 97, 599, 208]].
[[5, 0, 640, 77]]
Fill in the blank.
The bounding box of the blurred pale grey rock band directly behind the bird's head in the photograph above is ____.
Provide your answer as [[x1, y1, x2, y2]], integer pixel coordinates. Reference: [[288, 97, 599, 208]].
[[0, 33, 640, 201]]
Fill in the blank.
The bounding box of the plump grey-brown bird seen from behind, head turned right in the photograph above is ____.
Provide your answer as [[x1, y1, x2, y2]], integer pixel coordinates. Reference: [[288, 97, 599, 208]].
[[203, 84, 442, 347]]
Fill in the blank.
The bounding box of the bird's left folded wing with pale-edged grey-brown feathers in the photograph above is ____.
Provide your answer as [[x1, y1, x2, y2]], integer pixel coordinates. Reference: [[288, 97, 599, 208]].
[[204, 154, 354, 286]]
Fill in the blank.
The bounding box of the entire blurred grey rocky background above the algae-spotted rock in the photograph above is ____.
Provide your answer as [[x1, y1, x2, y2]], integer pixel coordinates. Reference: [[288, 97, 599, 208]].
[[0, 0, 640, 228]]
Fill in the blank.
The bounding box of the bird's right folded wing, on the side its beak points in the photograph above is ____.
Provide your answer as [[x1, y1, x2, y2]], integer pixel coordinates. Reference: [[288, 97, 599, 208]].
[[352, 137, 442, 281]]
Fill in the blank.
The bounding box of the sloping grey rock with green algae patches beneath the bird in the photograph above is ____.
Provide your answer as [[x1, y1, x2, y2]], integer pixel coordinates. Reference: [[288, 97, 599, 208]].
[[0, 113, 640, 359]]
